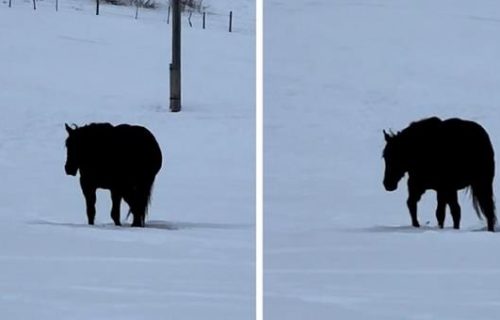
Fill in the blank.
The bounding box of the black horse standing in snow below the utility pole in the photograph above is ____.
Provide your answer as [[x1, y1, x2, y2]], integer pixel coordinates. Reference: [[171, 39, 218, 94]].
[[65, 123, 162, 227]]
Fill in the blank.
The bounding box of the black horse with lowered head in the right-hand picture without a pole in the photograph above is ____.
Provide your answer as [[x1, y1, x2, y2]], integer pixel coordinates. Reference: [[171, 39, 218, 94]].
[[383, 117, 496, 231]]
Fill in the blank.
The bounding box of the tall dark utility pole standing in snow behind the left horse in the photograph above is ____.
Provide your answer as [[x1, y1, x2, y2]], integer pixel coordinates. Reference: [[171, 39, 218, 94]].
[[170, 0, 181, 112]]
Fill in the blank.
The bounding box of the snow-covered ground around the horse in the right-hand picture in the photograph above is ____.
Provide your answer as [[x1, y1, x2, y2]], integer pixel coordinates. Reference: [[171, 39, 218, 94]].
[[264, 0, 500, 320]]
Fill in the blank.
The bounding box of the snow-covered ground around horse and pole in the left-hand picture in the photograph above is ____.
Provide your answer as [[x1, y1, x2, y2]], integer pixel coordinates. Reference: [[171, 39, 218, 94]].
[[0, 0, 255, 320]]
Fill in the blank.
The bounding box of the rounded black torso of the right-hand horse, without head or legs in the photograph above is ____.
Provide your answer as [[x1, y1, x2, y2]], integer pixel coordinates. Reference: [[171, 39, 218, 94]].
[[410, 118, 495, 189]]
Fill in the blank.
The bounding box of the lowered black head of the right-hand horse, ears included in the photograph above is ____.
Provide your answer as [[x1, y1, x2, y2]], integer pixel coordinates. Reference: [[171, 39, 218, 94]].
[[384, 130, 407, 191]]
